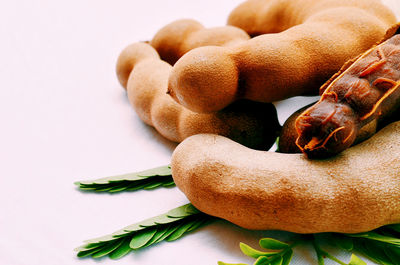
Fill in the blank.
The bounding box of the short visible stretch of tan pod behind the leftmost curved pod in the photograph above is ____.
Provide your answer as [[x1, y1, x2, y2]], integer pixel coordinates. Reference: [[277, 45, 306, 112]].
[[150, 19, 250, 65]]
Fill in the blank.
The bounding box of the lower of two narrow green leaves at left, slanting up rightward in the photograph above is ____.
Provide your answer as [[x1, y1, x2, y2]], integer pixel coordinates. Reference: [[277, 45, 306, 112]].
[[76, 204, 216, 259]]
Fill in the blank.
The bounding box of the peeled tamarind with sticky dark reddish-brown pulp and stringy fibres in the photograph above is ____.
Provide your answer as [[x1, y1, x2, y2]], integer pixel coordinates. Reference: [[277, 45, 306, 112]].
[[296, 29, 400, 158]]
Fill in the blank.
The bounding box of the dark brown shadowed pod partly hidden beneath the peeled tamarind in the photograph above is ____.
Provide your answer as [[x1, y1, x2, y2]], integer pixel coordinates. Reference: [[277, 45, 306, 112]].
[[278, 103, 378, 153]]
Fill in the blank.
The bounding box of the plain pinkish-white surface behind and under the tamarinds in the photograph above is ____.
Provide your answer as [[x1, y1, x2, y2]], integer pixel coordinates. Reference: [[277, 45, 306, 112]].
[[0, 0, 400, 265]]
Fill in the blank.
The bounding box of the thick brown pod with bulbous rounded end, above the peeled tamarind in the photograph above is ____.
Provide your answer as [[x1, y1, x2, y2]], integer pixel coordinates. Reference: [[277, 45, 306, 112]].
[[168, 0, 396, 112]]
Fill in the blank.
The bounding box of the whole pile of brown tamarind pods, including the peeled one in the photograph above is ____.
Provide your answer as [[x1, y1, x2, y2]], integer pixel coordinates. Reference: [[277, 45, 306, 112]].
[[117, 0, 400, 233]]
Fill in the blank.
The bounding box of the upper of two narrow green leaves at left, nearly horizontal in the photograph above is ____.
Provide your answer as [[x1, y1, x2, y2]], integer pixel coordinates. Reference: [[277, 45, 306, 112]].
[[75, 166, 175, 193]]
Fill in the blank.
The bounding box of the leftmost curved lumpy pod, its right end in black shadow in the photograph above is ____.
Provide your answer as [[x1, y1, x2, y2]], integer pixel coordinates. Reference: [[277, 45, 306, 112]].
[[117, 43, 280, 150]]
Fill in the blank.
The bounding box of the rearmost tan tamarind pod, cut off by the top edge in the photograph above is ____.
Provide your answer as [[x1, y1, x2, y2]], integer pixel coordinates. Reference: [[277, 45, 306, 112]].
[[228, 0, 395, 37]]
